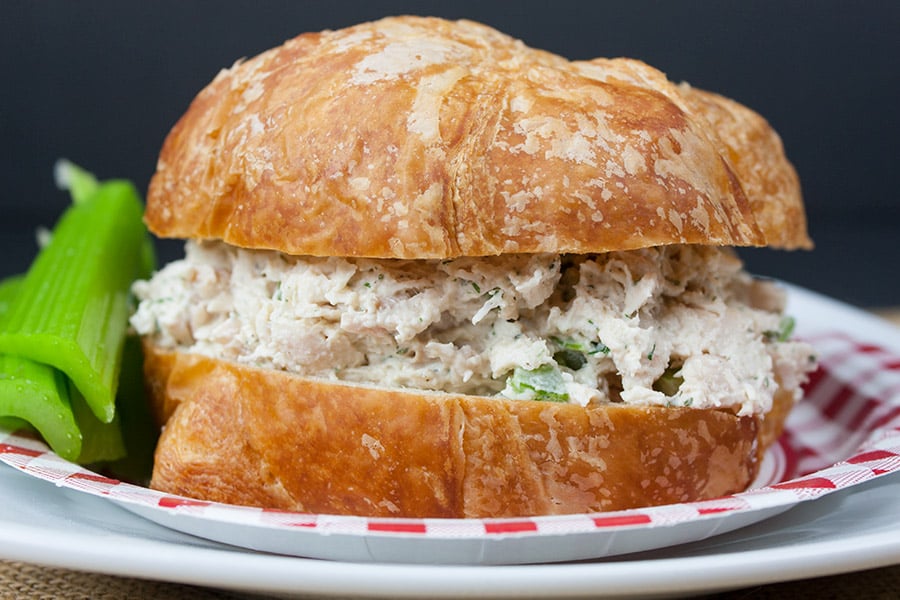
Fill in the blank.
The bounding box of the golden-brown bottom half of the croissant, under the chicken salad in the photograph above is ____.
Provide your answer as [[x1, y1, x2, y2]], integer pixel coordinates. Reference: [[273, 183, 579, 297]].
[[145, 342, 780, 517]]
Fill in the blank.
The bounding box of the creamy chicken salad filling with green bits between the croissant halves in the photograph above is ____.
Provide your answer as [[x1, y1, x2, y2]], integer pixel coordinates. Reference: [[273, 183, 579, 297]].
[[131, 241, 815, 415]]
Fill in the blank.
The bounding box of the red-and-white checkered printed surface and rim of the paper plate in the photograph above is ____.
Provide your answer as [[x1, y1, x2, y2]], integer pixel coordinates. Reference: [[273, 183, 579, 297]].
[[0, 333, 900, 539]]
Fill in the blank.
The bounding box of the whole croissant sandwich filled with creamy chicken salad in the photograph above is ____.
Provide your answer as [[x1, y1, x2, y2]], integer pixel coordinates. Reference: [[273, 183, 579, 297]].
[[132, 17, 815, 518]]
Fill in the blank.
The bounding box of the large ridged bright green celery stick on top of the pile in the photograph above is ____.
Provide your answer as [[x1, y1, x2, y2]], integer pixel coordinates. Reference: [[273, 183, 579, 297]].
[[0, 180, 149, 423]]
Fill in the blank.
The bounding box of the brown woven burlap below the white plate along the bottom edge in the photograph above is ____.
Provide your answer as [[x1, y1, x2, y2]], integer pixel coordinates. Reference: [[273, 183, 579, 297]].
[[0, 557, 900, 600]]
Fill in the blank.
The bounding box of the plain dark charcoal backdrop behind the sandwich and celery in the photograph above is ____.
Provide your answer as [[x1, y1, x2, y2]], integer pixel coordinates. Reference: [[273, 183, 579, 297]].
[[0, 0, 900, 306]]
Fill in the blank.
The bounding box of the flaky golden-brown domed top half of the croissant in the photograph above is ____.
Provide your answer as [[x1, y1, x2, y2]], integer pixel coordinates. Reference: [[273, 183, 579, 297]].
[[146, 17, 809, 258]]
